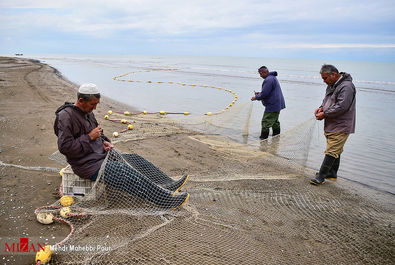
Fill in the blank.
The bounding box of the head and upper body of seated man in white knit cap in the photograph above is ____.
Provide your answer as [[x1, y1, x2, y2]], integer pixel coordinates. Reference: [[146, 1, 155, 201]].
[[54, 83, 113, 179]]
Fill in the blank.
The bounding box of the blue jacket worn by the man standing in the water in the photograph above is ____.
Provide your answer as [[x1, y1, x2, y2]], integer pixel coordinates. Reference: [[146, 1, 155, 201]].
[[255, 72, 285, 112]]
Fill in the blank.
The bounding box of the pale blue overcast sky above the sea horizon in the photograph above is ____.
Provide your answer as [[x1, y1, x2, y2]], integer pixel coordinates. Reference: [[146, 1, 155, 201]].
[[0, 0, 395, 62]]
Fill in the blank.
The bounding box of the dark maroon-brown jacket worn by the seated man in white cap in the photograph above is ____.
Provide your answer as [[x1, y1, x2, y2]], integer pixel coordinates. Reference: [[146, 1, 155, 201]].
[[54, 105, 108, 179]]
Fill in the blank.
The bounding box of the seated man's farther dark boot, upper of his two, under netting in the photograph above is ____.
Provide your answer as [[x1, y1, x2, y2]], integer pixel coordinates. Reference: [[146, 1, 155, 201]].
[[122, 154, 189, 191]]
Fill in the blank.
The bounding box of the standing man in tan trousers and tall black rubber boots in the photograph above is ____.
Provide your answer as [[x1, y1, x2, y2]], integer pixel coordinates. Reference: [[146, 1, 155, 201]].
[[310, 64, 356, 185]]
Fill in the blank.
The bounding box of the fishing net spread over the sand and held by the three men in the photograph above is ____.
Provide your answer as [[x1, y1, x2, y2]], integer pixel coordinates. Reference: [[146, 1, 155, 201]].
[[39, 98, 394, 264]]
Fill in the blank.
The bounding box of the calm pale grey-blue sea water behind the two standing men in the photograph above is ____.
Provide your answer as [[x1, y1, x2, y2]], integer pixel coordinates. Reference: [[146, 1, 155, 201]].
[[26, 55, 395, 194]]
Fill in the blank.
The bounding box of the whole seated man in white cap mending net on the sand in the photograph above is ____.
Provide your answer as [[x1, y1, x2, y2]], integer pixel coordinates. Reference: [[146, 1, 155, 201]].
[[54, 83, 189, 209]]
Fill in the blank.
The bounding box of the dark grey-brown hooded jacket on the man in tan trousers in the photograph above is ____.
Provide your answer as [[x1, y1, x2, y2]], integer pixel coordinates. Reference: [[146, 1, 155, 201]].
[[321, 73, 356, 133]]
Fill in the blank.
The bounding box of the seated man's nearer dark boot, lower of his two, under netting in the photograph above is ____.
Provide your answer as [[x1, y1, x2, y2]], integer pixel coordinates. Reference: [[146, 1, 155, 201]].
[[104, 162, 189, 209]]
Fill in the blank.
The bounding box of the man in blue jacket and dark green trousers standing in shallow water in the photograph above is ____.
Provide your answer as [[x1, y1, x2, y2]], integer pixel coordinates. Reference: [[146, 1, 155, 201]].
[[251, 66, 285, 140]]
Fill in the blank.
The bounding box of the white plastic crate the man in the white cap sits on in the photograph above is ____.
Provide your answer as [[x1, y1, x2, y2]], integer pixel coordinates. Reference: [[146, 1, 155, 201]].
[[62, 165, 95, 196]]
